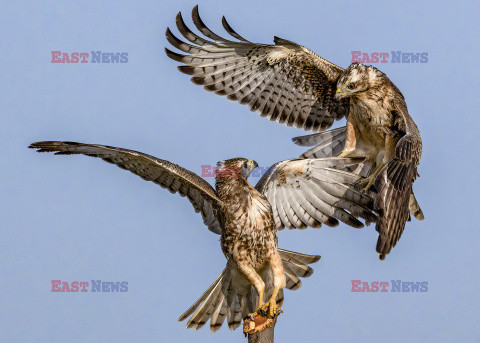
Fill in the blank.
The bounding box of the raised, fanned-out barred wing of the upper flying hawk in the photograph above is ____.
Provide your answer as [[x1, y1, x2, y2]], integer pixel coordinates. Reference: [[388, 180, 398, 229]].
[[165, 6, 349, 131]]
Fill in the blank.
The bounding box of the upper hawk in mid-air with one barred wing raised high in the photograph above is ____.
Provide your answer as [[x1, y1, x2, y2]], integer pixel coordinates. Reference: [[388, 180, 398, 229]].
[[165, 6, 423, 259]]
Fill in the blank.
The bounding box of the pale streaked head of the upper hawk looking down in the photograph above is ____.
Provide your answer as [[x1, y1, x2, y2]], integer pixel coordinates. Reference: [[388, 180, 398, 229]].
[[335, 63, 384, 99]]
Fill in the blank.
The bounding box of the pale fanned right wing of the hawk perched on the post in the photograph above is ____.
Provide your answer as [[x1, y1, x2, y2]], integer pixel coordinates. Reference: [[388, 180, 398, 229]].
[[255, 158, 376, 230]]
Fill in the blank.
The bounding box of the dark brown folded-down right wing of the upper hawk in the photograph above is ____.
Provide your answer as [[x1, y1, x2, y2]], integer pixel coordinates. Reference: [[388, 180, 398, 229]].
[[374, 99, 423, 260]]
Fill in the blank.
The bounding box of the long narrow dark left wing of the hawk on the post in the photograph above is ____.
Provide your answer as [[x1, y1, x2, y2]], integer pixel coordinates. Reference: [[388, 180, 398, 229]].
[[29, 141, 222, 234]]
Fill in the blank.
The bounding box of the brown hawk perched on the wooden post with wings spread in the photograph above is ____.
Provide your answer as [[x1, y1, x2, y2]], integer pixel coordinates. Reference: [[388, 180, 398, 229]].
[[29, 141, 375, 331]]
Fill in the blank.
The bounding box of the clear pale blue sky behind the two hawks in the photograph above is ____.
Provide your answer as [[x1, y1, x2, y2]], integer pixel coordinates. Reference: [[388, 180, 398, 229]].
[[0, 1, 480, 342]]
